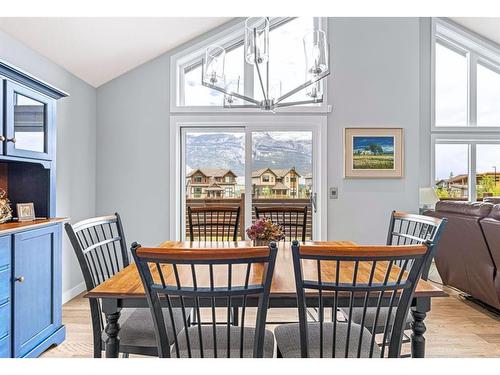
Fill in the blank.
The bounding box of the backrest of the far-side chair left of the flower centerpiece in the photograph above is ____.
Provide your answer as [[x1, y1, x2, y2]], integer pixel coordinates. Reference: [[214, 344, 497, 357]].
[[188, 206, 240, 241]]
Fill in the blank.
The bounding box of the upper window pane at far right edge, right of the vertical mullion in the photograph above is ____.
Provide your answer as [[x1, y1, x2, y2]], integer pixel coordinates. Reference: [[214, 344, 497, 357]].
[[477, 64, 500, 126]]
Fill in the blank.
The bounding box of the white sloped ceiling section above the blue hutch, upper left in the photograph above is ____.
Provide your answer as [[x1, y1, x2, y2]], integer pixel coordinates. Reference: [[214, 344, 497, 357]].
[[0, 17, 230, 87]]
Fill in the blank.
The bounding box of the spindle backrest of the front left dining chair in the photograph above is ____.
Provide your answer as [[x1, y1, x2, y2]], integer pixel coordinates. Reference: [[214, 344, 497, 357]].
[[132, 242, 277, 358]]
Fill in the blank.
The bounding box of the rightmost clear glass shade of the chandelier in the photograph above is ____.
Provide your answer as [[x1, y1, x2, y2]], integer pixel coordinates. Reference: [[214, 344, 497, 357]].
[[303, 30, 328, 78]]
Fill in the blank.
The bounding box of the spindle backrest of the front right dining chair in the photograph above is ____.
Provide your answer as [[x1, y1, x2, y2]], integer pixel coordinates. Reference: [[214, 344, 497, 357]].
[[292, 241, 433, 357]]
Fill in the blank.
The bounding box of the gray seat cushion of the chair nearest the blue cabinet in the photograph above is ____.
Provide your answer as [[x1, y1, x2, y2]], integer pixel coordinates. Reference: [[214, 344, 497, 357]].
[[102, 308, 188, 355]]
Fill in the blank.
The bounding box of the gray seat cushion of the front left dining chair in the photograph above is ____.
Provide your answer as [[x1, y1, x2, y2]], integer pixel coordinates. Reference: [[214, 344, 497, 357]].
[[171, 325, 274, 358]]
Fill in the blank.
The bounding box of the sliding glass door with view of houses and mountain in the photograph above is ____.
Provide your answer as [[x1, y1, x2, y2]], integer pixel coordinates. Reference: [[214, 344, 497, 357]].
[[176, 117, 326, 240]]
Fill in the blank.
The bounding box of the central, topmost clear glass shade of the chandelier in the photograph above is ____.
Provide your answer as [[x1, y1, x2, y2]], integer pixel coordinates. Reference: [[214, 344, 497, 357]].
[[245, 17, 269, 65]]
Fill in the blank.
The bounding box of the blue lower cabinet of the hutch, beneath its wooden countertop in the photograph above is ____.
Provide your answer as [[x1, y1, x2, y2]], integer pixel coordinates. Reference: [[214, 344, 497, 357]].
[[0, 224, 65, 357]]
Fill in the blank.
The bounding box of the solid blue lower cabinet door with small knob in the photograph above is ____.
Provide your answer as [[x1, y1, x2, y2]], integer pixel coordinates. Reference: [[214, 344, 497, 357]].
[[13, 225, 62, 357]]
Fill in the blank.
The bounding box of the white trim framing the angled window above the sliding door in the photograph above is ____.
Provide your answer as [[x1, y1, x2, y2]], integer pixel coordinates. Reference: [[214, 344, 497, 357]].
[[170, 17, 332, 115]]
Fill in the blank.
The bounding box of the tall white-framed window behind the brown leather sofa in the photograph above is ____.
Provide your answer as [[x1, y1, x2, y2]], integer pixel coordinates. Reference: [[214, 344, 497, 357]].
[[432, 19, 500, 201]]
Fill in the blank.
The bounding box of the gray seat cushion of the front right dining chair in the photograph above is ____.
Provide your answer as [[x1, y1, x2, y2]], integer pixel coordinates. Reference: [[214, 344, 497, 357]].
[[274, 322, 380, 358]]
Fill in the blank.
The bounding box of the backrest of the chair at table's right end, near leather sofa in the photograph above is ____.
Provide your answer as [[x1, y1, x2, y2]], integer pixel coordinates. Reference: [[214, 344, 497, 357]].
[[387, 211, 446, 280]]
